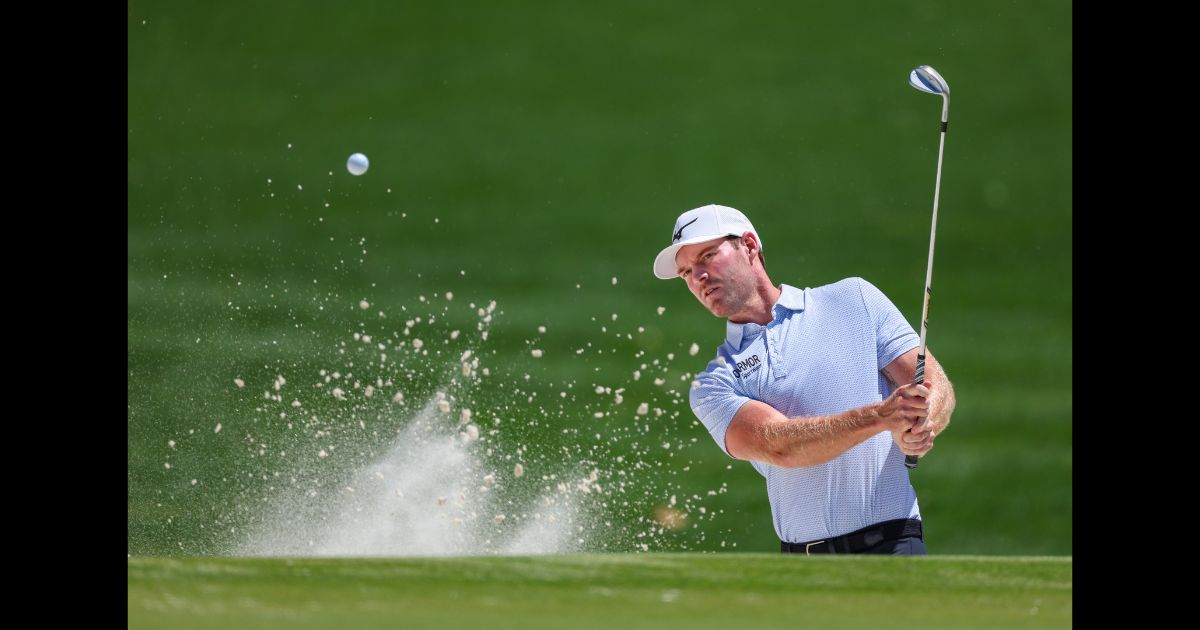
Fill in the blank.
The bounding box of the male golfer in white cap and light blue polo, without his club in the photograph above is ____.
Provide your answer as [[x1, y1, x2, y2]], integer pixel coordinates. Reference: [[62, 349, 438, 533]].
[[654, 205, 954, 556]]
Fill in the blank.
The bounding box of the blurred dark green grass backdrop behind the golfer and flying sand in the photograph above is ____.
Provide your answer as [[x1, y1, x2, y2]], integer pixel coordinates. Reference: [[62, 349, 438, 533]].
[[127, 0, 1072, 554]]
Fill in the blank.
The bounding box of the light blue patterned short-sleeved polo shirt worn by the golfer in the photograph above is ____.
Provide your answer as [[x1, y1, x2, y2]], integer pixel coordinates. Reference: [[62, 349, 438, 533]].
[[691, 277, 920, 542]]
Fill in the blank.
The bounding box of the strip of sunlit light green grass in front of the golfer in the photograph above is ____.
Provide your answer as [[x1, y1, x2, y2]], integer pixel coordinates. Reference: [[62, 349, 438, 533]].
[[128, 553, 1073, 630]]
